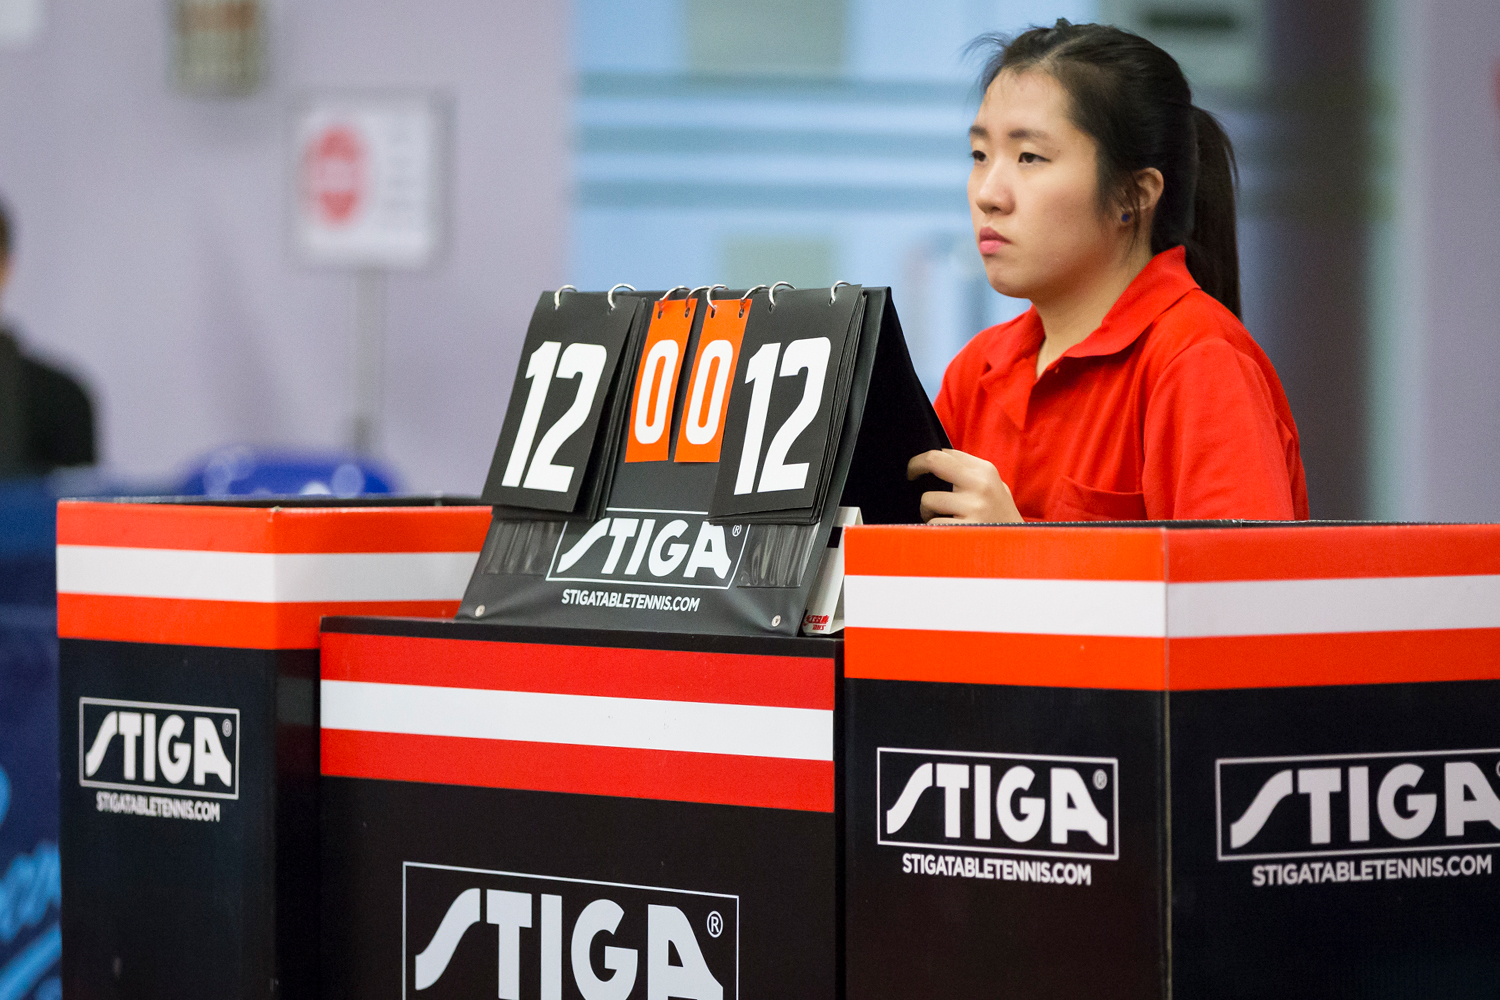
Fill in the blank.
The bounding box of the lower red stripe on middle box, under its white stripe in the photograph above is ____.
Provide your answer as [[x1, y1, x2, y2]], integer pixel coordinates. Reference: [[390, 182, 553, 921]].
[[323, 729, 834, 813]]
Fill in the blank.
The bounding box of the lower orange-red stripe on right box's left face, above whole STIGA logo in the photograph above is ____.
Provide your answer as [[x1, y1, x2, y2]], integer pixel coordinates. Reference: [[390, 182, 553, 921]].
[[845, 628, 1166, 691]]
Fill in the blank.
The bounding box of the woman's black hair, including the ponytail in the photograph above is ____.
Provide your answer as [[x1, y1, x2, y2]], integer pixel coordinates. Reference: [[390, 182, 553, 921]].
[[971, 18, 1241, 316]]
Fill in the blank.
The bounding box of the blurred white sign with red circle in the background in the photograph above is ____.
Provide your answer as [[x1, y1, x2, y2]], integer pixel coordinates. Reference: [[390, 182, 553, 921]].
[[293, 94, 447, 268]]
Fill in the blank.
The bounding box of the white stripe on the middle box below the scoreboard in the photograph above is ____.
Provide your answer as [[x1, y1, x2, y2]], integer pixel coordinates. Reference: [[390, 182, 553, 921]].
[[320, 681, 834, 760]]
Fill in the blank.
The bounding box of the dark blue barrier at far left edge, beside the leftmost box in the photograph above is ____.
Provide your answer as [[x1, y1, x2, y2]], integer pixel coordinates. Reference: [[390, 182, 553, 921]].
[[0, 480, 62, 1000]]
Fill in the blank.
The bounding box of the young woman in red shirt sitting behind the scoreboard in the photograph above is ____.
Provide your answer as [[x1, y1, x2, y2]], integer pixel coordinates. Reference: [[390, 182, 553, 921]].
[[908, 21, 1308, 523]]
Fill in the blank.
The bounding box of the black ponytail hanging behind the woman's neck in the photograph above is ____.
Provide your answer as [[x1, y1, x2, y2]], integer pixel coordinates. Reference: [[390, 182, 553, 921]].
[[1184, 108, 1242, 318]]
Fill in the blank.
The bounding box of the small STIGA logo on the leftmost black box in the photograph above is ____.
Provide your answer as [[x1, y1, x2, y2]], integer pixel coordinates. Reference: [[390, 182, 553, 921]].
[[78, 699, 240, 808]]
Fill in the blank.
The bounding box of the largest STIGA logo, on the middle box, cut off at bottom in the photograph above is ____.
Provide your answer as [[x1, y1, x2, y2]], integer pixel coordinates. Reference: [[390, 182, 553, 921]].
[[402, 862, 740, 1000]]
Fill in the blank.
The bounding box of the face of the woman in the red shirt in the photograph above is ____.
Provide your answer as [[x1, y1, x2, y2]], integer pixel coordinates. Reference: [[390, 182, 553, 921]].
[[969, 70, 1121, 300]]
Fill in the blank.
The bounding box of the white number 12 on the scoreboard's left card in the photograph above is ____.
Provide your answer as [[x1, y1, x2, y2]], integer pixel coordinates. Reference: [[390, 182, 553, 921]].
[[500, 340, 609, 493]]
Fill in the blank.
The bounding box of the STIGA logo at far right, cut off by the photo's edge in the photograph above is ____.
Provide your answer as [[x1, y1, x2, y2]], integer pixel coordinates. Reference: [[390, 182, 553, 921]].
[[1214, 750, 1500, 861]]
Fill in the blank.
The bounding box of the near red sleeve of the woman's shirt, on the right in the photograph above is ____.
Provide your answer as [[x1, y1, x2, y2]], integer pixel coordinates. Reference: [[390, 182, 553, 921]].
[[1142, 340, 1307, 520]]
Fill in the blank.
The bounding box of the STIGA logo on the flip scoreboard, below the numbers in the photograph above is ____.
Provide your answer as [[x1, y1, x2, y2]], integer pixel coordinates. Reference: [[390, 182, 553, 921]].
[[548, 510, 749, 591]]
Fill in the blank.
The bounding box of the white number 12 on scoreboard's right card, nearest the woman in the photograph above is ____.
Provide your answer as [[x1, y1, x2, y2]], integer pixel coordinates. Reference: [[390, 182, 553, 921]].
[[735, 337, 833, 495]]
